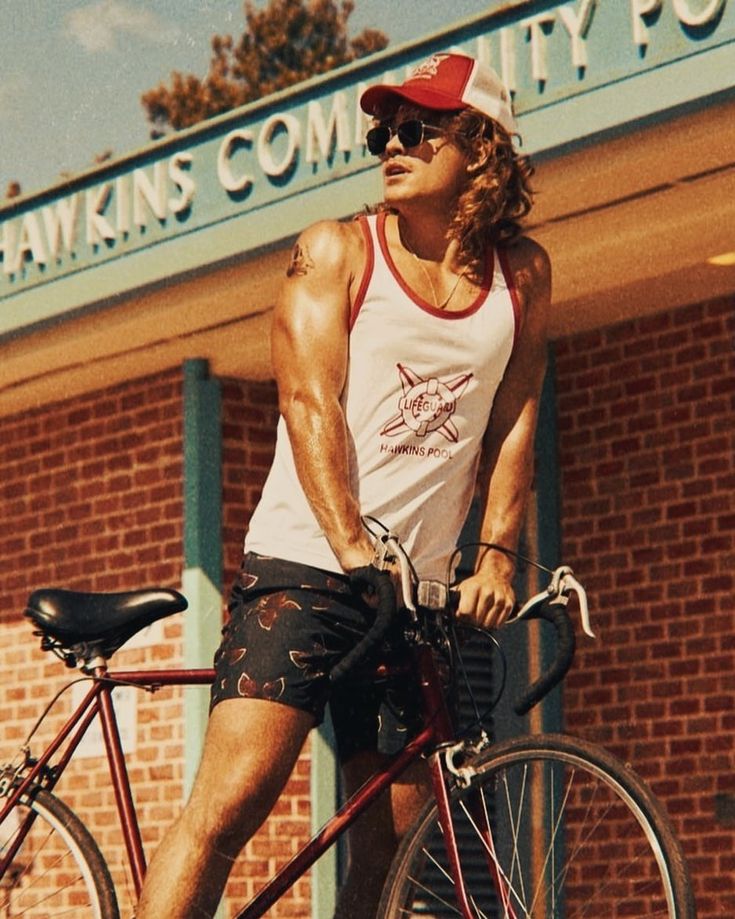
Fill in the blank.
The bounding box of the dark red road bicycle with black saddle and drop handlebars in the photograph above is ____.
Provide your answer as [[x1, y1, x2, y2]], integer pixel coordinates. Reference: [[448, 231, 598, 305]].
[[0, 531, 696, 919]]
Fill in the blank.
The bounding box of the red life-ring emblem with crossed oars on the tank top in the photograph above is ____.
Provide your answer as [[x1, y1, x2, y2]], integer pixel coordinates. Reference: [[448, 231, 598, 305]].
[[380, 364, 472, 444]]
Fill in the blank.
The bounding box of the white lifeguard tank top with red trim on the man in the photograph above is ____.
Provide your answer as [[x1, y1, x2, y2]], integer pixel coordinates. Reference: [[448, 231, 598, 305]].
[[245, 214, 520, 578]]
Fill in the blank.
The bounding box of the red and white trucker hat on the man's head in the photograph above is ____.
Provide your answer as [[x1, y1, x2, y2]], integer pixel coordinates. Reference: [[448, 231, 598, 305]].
[[360, 53, 517, 134]]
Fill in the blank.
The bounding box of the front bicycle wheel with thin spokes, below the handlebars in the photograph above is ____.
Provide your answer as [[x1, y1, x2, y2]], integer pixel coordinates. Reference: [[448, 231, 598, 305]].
[[378, 735, 695, 919]]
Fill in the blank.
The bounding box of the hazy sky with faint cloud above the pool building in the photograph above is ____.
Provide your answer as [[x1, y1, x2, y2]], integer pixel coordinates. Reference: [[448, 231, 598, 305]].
[[0, 0, 498, 199]]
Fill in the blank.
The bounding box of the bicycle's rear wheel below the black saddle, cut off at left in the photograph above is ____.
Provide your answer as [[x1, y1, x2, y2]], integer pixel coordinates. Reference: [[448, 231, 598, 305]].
[[0, 789, 119, 919]]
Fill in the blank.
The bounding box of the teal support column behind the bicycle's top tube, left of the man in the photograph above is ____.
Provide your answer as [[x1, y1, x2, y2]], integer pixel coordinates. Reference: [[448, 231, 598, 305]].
[[182, 360, 222, 796]]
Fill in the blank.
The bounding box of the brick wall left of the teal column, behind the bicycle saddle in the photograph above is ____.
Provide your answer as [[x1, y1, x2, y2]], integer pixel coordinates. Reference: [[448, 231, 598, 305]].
[[0, 370, 183, 912]]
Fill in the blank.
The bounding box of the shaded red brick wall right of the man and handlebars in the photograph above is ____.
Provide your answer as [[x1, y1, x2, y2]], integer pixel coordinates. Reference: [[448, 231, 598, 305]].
[[557, 299, 735, 919]]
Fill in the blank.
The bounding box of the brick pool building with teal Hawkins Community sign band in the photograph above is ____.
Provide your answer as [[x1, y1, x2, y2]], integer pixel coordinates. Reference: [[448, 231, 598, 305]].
[[0, 0, 735, 919]]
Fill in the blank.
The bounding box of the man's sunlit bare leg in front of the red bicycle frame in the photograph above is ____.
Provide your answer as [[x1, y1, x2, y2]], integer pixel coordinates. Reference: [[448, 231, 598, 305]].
[[136, 699, 314, 919]]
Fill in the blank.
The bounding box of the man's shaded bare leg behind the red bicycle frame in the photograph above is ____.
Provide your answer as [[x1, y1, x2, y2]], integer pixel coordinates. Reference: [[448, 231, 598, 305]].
[[334, 753, 431, 919]]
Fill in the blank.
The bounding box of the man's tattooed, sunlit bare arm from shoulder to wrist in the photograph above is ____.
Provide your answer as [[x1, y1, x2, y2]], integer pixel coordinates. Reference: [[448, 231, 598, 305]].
[[271, 221, 372, 571]]
